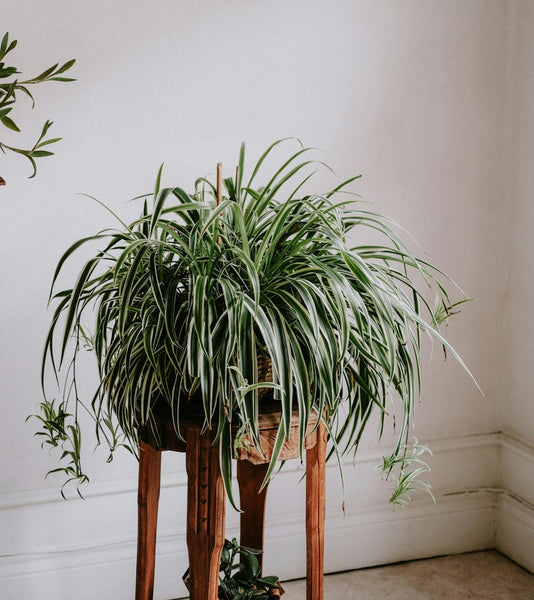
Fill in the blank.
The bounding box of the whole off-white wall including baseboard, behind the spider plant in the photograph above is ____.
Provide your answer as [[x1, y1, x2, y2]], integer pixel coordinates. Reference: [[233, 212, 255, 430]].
[[0, 0, 534, 600]]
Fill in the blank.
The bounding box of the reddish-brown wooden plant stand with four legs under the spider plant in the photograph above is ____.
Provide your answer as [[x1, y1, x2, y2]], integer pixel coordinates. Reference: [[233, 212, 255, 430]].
[[135, 407, 327, 600]]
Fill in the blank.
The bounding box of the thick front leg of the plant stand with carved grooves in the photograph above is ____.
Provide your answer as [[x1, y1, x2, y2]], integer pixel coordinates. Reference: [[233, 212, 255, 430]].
[[186, 427, 224, 600]]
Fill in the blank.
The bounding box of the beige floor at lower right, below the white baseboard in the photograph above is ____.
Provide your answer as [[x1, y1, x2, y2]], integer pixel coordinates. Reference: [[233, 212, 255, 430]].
[[283, 550, 534, 600]]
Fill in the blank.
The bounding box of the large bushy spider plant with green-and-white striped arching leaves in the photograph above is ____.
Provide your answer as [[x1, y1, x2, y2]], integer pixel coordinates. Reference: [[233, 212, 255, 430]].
[[33, 140, 472, 500]]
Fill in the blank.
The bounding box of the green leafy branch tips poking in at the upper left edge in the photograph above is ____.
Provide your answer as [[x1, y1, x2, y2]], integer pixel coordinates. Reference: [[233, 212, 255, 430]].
[[0, 33, 75, 185]]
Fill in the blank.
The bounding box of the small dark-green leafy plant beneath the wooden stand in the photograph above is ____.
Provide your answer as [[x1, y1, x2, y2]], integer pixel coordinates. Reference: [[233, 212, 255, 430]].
[[183, 538, 284, 600]]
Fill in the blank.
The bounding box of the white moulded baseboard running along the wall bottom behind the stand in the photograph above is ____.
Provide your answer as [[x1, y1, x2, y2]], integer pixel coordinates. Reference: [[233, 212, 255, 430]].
[[0, 433, 534, 600]]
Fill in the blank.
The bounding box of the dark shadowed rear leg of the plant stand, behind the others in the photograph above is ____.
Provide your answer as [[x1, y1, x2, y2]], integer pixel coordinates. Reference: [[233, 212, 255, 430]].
[[237, 460, 269, 567]]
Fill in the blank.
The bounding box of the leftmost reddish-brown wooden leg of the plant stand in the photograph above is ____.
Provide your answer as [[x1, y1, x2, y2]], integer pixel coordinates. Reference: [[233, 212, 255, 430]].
[[135, 442, 161, 600]]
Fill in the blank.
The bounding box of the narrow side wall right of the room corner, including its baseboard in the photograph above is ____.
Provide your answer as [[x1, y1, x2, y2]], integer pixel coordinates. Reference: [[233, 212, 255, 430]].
[[497, 0, 534, 569]]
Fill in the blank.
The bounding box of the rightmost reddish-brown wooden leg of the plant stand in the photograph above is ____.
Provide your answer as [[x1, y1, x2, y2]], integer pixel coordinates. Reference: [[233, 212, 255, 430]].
[[306, 423, 326, 600]]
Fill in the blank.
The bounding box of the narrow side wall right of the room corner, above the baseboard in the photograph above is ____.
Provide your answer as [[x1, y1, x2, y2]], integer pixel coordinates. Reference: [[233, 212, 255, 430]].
[[508, 2, 534, 450]]
